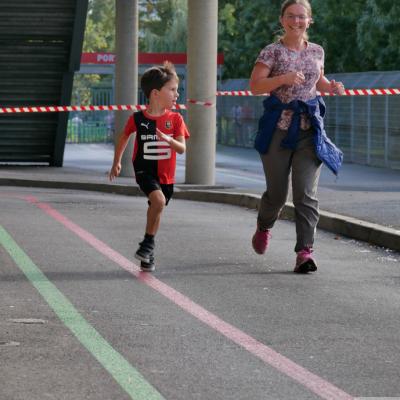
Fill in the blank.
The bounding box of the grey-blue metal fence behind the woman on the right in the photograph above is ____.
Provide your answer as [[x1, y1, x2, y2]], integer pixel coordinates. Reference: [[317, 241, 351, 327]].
[[217, 71, 400, 169]]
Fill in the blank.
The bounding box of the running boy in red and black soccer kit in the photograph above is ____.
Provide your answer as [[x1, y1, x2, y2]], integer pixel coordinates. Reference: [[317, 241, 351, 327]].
[[109, 62, 189, 271]]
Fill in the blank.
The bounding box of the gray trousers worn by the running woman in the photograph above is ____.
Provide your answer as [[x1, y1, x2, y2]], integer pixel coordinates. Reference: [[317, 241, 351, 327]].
[[257, 129, 322, 251]]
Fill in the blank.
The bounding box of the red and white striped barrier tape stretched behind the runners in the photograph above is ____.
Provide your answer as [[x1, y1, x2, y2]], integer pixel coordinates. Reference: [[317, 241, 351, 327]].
[[0, 89, 400, 114]]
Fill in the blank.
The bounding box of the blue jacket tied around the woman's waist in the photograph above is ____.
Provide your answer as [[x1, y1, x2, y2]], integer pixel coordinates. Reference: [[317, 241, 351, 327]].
[[254, 95, 343, 175]]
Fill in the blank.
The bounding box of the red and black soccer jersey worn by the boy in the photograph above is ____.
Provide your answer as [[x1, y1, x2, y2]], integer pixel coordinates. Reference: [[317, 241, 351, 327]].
[[124, 110, 189, 184]]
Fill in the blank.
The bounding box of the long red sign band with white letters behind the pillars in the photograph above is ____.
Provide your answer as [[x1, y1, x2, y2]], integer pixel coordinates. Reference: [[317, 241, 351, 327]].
[[81, 53, 224, 65]]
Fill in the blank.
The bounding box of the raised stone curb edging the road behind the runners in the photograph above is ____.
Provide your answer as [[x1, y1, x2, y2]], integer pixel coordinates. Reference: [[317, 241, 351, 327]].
[[0, 178, 400, 251]]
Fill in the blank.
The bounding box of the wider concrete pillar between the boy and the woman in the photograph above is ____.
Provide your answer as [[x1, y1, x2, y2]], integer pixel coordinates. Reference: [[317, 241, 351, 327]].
[[186, 0, 218, 185]]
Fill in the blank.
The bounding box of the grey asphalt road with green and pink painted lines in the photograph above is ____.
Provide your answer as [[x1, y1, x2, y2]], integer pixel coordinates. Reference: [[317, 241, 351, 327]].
[[0, 187, 400, 400]]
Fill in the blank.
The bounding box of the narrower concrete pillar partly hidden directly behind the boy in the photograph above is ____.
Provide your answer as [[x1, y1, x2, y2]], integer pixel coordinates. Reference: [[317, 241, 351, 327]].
[[114, 0, 139, 176]]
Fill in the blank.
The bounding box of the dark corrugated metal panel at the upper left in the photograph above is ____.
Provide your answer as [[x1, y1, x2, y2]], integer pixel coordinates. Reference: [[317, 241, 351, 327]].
[[0, 0, 87, 164]]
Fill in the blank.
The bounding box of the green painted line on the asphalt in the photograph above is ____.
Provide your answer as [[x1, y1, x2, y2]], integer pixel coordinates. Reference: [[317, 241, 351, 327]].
[[0, 225, 165, 400]]
